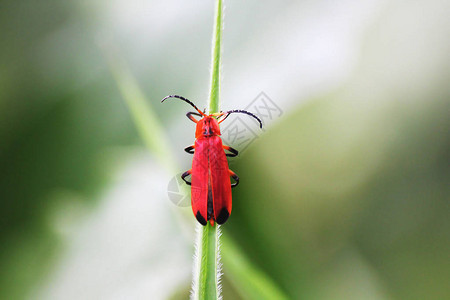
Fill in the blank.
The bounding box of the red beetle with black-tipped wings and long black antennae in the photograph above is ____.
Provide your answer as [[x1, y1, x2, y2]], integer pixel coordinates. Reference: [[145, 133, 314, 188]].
[[161, 95, 262, 226]]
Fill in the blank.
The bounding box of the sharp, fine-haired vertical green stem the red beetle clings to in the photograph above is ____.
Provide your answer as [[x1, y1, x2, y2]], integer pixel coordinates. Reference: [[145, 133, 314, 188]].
[[193, 0, 223, 300]]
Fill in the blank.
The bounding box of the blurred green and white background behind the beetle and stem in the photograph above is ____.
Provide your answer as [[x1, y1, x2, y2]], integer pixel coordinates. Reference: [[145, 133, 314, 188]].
[[0, 0, 450, 299]]
